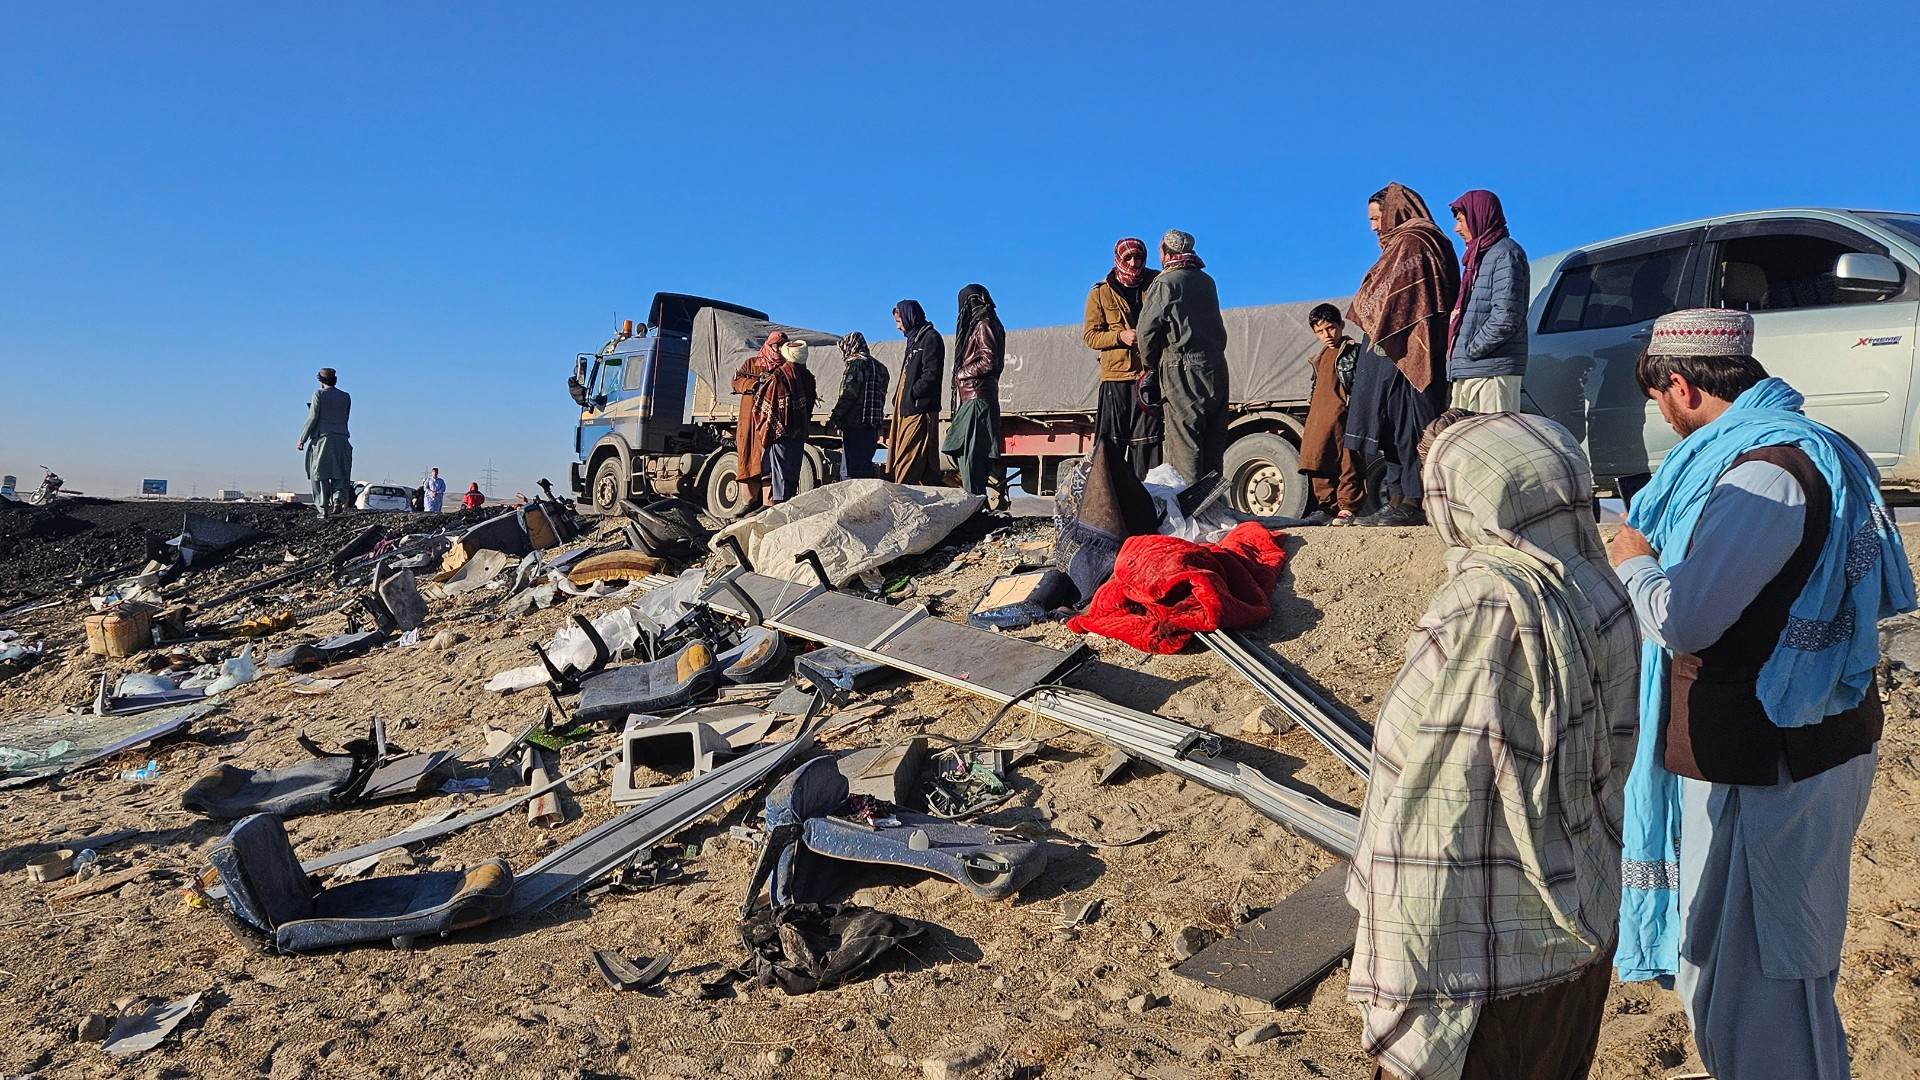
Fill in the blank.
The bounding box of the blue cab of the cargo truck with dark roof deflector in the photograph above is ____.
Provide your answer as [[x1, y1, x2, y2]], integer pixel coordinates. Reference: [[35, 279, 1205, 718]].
[[566, 292, 766, 513]]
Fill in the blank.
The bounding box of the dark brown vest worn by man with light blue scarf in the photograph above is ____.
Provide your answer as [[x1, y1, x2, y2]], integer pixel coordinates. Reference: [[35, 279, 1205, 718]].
[[1661, 446, 1885, 784]]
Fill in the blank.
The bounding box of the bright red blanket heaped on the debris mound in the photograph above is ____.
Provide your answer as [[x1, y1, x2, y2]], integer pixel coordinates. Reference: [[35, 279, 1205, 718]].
[[1068, 521, 1286, 653]]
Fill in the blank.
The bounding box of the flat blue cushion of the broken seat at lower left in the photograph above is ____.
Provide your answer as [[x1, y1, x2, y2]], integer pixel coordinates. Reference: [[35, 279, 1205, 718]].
[[273, 859, 513, 953]]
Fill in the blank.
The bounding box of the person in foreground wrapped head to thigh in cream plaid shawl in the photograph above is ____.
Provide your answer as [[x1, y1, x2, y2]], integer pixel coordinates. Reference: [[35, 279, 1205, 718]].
[[1346, 411, 1640, 1080]]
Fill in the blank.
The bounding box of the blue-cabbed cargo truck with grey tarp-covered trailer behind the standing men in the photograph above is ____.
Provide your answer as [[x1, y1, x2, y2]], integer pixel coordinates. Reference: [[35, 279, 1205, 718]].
[[568, 292, 1344, 517]]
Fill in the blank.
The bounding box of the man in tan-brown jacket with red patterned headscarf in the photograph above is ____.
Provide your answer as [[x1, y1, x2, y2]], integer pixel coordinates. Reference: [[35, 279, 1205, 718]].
[[1081, 236, 1160, 477]]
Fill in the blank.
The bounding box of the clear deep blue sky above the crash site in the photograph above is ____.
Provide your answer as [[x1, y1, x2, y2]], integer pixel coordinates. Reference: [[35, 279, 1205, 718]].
[[0, 0, 1920, 494]]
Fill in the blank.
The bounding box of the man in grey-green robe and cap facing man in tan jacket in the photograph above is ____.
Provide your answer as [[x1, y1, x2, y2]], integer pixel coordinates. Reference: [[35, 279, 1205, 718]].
[[1139, 229, 1227, 484]]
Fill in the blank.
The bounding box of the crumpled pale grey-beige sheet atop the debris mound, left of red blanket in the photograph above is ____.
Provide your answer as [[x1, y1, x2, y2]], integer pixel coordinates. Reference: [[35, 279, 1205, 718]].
[[716, 480, 987, 586]]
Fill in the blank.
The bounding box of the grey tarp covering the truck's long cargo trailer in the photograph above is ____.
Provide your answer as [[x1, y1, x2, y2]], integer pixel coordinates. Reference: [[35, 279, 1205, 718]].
[[687, 300, 1346, 421]]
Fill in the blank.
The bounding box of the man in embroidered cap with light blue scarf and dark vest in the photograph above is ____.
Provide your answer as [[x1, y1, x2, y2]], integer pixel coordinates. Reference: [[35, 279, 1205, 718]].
[[1611, 309, 1914, 1080]]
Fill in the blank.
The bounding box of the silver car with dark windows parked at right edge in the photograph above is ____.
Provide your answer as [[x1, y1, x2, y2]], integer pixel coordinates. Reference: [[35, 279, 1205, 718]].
[[1524, 209, 1920, 492]]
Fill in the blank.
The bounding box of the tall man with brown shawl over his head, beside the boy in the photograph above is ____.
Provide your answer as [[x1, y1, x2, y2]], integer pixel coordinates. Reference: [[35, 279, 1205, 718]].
[[1346, 184, 1459, 525]]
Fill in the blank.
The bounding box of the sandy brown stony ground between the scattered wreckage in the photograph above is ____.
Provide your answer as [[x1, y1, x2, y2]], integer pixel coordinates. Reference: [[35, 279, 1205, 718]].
[[0, 507, 1920, 1080]]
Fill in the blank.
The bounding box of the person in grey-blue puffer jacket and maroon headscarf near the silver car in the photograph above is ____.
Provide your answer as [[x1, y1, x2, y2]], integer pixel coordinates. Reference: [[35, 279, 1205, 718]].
[[1446, 188, 1532, 413]]
